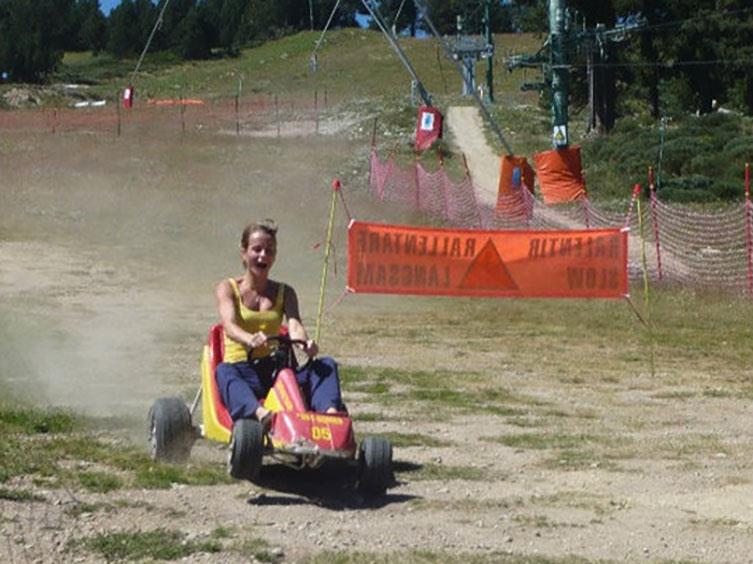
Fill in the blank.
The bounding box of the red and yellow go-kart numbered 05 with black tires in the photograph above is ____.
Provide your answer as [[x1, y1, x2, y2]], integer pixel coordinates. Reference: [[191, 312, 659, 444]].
[[148, 325, 394, 495]]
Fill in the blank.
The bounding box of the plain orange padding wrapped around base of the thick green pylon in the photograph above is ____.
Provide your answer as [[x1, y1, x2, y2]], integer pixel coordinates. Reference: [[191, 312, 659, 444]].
[[533, 147, 586, 205]]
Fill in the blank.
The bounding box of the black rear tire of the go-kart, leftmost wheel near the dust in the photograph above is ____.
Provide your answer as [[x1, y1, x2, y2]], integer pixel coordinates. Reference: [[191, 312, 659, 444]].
[[147, 398, 196, 463]]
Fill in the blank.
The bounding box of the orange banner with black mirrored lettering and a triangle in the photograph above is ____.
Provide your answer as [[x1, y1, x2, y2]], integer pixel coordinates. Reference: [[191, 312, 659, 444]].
[[348, 221, 628, 298]]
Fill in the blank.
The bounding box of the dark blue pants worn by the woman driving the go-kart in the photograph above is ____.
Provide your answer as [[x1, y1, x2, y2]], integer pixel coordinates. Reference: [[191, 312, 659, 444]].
[[217, 356, 345, 421]]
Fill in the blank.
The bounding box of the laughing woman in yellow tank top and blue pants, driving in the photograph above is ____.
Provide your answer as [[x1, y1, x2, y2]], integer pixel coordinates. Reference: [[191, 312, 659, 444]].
[[215, 220, 345, 429]]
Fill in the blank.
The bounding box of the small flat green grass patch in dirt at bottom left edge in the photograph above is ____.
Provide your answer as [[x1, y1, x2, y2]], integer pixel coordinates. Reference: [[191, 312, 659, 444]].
[[69, 529, 222, 561]]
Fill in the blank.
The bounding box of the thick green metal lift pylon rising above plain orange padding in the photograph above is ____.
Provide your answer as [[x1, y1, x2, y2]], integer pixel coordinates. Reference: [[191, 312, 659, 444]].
[[549, 0, 570, 148]]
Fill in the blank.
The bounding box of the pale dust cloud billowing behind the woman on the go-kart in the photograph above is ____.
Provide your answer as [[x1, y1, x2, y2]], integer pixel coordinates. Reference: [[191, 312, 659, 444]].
[[0, 126, 412, 416]]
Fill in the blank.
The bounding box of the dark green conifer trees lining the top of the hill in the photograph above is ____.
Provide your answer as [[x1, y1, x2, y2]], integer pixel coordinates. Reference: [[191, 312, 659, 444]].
[[0, 0, 753, 120]]
